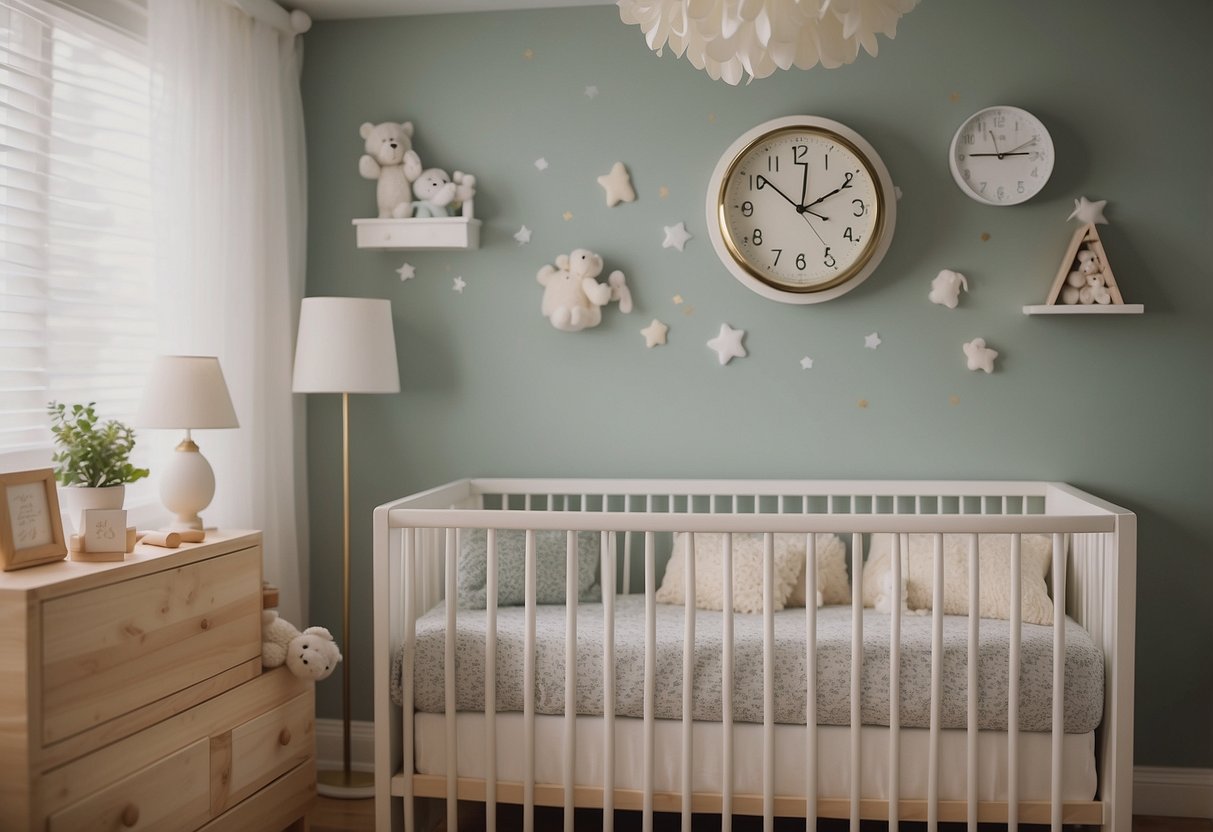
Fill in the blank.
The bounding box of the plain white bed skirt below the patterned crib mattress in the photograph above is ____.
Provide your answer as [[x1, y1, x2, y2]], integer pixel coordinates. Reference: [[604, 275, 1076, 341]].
[[415, 712, 1097, 800]]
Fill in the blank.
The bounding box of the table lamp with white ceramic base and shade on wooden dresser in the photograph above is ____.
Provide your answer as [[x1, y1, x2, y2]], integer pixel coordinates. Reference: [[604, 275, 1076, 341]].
[[135, 355, 240, 529]]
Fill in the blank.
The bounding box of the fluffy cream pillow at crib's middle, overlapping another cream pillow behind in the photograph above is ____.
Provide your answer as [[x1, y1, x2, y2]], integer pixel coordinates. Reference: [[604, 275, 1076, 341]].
[[656, 531, 804, 612]]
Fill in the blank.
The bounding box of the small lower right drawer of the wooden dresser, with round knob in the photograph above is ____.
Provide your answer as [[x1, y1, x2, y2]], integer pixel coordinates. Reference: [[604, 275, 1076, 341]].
[[227, 694, 315, 805]]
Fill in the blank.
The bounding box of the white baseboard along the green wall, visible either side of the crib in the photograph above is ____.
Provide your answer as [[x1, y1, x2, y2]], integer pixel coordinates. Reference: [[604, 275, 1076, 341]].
[[315, 719, 1213, 817]]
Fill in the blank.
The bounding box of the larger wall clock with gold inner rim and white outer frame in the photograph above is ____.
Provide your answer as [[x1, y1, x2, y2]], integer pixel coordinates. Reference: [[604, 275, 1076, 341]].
[[706, 115, 896, 303]]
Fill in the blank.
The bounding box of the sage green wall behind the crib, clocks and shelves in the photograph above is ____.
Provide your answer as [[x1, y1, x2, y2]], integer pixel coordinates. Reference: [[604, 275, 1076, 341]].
[[303, 0, 1213, 767]]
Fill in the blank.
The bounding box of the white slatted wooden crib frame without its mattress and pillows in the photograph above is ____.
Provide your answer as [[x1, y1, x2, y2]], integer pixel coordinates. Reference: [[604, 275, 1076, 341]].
[[375, 479, 1135, 832]]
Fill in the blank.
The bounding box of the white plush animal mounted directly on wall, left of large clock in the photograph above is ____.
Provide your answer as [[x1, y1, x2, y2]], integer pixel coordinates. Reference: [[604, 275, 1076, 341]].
[[536, 249, 632, 332]]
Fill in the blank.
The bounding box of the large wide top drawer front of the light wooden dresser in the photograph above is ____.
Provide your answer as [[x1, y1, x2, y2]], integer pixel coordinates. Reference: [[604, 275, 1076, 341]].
[[41, 547, 261, 742]]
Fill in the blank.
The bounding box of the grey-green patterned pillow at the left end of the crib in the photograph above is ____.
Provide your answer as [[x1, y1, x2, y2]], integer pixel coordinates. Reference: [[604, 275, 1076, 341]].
[[456, 529, 602, 610]]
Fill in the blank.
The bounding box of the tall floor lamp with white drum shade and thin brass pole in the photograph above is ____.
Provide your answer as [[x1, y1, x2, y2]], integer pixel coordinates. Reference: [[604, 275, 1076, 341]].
[[292, 297, 400, 798]]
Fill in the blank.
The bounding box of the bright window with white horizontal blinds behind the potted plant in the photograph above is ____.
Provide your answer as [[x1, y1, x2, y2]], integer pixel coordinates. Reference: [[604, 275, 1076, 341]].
[[0, 0, 156, 494]]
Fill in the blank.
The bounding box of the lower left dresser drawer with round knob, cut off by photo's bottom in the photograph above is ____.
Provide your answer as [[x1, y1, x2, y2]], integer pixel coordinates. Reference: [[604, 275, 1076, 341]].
[[46, 740, 210, 832]]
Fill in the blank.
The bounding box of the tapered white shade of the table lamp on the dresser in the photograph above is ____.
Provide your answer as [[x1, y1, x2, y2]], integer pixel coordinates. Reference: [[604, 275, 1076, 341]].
[[135, 355, 240, 429]]
